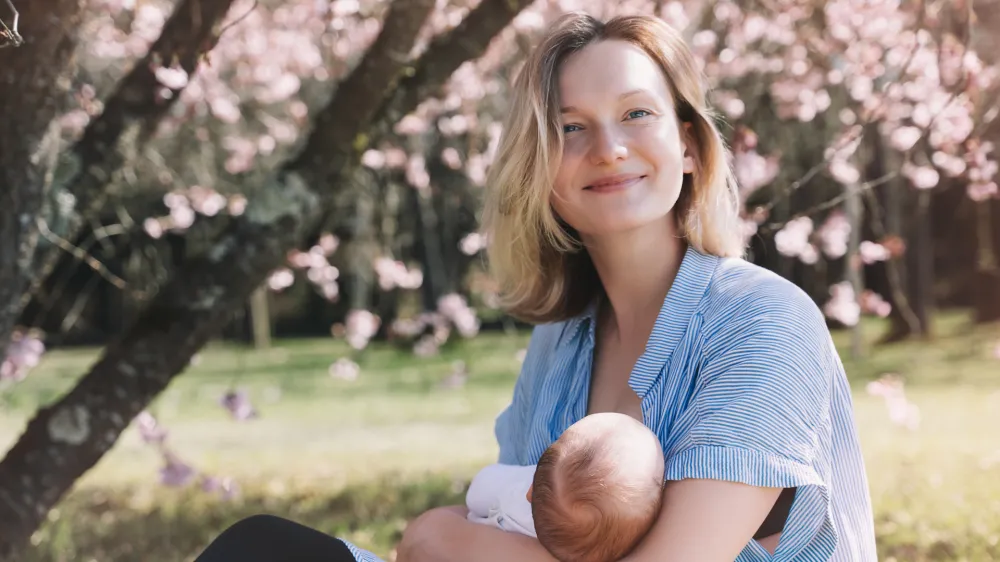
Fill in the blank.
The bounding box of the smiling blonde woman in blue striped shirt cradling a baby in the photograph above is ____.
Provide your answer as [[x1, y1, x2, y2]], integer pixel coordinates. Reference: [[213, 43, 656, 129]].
[[193, 9, 876, 562]]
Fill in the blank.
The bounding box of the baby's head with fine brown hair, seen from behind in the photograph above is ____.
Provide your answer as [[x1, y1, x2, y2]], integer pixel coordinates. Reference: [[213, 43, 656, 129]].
[[528, 413, 663, 562]]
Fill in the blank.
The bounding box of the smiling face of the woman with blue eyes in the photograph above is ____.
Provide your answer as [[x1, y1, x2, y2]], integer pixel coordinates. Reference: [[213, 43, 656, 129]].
[[551, 41, 694, 240]]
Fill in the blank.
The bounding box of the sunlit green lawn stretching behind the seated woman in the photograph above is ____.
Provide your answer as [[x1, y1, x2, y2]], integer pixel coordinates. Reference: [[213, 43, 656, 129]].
[[0, 315, 1000, 562]]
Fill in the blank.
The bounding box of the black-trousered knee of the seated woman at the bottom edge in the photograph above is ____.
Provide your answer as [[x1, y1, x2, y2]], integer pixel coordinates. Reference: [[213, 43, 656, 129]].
[[195, 515, 355, 562]]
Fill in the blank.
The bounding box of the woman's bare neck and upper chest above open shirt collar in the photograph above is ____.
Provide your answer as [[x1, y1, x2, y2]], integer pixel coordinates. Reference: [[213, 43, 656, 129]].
[[585, 215, 687, 342]]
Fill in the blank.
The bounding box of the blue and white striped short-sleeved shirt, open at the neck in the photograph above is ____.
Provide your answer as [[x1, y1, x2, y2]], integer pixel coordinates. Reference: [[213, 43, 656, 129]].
[[342, 248, 877, 562]]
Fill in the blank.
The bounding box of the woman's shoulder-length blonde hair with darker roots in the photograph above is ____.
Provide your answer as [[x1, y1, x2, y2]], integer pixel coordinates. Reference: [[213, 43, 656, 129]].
[[483, 13, 745, 323]]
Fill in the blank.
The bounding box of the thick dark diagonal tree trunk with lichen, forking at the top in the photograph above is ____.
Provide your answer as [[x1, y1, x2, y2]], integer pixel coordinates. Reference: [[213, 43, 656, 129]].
[[0, 0, 529, 559]]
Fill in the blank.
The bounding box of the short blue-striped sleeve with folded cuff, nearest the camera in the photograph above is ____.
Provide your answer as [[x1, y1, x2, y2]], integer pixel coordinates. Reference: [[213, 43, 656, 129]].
[[665, 280, 843, 561]]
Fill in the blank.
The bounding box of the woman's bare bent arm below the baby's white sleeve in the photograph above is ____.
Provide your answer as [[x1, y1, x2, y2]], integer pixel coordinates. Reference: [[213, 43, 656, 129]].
[[396, 506, 560, 562]]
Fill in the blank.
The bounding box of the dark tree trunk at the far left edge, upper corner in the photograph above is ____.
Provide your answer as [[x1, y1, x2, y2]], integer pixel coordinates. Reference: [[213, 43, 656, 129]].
[[0, 0, 82, 352]]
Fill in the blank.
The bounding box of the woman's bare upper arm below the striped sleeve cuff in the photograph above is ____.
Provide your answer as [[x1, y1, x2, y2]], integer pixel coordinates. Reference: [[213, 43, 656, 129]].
[[623, 479, 781, 562]]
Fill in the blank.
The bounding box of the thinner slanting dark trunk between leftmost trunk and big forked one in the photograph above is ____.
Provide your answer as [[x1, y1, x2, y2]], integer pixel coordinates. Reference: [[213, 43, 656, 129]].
[[18, 0, 239, 318]]
